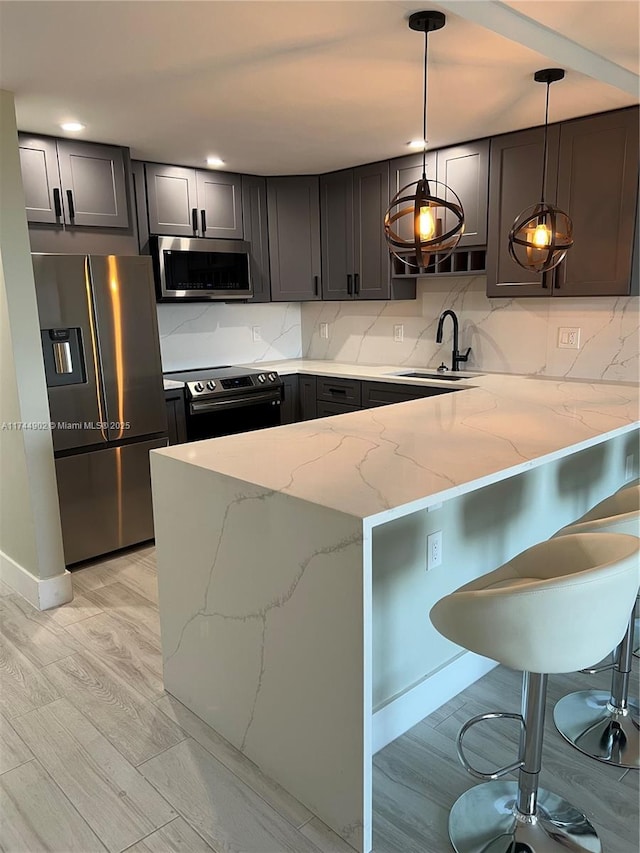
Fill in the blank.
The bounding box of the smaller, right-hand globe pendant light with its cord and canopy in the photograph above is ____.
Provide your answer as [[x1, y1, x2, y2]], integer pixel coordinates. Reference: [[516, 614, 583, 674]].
[[509, 68, 573, 273]]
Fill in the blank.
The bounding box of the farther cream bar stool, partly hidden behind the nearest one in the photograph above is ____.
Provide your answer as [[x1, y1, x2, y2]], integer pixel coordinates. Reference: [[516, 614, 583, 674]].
[[553, 485, 640, 769]]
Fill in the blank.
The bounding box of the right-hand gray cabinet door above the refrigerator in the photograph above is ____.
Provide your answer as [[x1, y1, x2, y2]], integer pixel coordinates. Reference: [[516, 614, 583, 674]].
[[58, 139, 129, 228]]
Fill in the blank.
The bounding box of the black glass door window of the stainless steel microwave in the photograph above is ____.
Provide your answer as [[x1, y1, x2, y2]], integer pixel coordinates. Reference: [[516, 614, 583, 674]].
[[163, 249, 250, 293]]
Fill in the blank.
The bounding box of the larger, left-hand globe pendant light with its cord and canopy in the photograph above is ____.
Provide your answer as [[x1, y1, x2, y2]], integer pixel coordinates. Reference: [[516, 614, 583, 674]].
[[384, 12, 464, 269]]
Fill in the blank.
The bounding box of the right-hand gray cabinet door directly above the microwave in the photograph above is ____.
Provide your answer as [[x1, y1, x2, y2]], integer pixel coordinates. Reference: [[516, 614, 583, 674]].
[[196, 169, 242, 240]]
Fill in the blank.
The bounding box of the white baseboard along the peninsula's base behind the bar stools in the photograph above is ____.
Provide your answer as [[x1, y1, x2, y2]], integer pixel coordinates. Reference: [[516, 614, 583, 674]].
[[372, 652, 498, 754]]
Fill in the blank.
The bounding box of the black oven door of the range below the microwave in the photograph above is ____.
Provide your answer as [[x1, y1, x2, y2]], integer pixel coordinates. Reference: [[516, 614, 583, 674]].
[[187, 388, 282, 441]]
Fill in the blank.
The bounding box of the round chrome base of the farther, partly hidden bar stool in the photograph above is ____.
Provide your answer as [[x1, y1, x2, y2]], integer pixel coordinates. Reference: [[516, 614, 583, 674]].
[[553, 690, 640, 768]]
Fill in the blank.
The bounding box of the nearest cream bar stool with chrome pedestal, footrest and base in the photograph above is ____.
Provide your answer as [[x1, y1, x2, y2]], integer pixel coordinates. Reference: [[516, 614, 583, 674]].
[[429, 533, 640, 853]]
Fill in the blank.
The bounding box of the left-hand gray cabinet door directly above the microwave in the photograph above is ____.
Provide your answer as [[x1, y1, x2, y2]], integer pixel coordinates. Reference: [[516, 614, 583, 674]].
[[145, 163, 200, 237]]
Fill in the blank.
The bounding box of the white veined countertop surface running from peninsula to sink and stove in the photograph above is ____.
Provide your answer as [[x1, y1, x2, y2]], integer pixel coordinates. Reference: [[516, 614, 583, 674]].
[[153, 359, 640, 523]]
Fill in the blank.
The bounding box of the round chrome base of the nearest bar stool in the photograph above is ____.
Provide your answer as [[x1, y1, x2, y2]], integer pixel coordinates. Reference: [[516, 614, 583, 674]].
[[449, 781, 602, 853]]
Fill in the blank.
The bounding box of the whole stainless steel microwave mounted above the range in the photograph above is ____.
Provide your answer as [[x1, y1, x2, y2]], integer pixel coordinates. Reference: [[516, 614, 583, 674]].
[[149, 236, 253, 302]]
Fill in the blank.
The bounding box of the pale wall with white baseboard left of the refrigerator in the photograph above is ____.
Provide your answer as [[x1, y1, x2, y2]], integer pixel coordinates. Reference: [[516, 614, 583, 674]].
[[0, 91, 71, 609]]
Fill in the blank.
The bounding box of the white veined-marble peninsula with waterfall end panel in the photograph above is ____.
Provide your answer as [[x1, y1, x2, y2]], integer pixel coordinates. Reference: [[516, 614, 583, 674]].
[[151, 363, 639, 851]]
